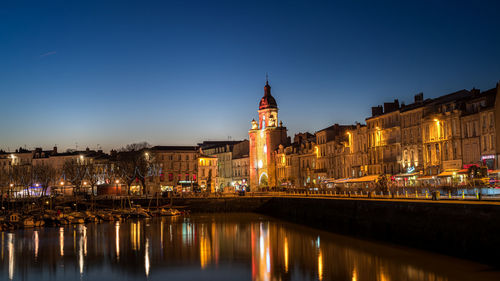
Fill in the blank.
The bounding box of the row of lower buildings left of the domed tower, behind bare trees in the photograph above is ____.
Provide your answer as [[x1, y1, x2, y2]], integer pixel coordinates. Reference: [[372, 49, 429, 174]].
[[0, 140, 249, 194]]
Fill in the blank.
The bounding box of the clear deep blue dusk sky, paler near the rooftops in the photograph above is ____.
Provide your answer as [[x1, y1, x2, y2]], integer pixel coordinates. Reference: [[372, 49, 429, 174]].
[[0, 0, 500, 151]]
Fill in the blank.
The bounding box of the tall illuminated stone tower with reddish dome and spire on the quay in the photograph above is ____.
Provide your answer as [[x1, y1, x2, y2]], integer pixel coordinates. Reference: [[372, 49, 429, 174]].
[[248, 81, 287, 188]]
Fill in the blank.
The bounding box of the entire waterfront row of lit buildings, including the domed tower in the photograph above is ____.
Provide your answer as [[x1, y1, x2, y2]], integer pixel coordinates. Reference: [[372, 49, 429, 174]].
[[0, 81, 500, 193]]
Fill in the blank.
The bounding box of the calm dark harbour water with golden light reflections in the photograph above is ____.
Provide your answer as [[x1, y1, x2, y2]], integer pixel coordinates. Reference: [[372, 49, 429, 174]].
[[0, 214, 500, 281]]
